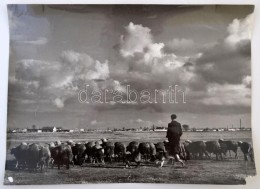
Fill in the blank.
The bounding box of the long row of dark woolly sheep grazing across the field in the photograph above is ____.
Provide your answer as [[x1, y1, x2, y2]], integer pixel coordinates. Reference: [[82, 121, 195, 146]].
[[11, 139, 254, 171]]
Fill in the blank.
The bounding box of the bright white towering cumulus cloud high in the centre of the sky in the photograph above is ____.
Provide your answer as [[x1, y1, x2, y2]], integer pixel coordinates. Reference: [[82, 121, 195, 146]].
[[119, 22, 191, 86]]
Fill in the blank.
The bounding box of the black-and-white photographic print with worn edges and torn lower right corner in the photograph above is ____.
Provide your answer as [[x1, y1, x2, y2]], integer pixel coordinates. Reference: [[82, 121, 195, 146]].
[[3, 4, 256, 185]]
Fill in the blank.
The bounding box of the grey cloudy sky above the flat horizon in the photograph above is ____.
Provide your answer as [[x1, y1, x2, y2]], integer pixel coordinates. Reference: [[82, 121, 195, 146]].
[[8, 5, 253, 128]]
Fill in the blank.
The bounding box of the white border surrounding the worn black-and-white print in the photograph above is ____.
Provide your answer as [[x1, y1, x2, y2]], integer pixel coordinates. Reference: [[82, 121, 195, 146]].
[[0, 0, 260, 189]]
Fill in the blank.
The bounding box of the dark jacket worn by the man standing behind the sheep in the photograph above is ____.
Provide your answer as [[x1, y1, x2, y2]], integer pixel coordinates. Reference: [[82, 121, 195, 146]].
[[166, 121, 182, 141]]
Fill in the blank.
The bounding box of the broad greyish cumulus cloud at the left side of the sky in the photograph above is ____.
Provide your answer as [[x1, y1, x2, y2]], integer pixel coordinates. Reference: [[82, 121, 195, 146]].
[[12, 51, 109, 108]]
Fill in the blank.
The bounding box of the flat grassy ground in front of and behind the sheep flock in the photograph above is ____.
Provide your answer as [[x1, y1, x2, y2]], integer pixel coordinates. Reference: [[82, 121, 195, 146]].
[[4, 132, 255, 185]]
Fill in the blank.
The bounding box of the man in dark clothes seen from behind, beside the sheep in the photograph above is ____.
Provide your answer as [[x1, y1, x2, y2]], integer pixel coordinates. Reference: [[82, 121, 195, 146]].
[[166, 114, 184, 166]]
